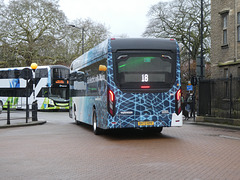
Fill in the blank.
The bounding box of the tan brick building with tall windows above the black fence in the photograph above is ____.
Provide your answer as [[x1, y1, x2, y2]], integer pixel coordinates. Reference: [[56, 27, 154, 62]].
[[211, 0, 240, 78]]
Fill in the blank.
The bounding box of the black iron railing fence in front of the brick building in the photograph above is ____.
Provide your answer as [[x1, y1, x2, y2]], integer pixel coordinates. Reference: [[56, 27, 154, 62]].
[[199, 76, 240, 119]]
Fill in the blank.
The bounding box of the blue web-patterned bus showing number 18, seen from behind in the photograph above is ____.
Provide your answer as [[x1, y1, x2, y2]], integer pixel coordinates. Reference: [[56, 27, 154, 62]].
[[69, 38, 182, 134]]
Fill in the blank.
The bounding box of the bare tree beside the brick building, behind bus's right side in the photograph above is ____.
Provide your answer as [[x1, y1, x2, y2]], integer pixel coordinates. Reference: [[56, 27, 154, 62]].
[[143, 0, 211, 60]]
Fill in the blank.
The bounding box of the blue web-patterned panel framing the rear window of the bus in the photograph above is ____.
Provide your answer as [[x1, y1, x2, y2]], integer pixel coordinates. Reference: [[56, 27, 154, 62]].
[[107, 40, 181, 128]]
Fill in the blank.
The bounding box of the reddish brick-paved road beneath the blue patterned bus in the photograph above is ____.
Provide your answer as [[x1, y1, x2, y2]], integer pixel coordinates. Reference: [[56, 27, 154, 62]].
[[0, 112, 240, 180]]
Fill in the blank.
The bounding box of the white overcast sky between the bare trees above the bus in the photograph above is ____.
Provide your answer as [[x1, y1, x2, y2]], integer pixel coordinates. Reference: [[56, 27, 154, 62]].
[[59, 0, 169, 37]]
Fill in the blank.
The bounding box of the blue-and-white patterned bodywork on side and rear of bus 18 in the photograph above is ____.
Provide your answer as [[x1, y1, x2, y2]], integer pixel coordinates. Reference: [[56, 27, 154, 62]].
[[70, 39, 182, 129]]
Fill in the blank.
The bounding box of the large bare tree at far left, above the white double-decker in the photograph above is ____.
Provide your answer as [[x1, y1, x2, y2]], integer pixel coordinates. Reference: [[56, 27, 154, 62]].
[[1, 0, 67, 65]]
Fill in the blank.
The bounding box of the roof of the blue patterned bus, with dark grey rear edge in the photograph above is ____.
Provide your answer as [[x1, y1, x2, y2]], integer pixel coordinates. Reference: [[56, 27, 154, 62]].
[[71, 38, 177, 70]]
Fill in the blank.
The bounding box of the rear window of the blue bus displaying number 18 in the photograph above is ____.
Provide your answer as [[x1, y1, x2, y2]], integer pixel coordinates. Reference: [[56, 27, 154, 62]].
[[115, 52, 176, 89]]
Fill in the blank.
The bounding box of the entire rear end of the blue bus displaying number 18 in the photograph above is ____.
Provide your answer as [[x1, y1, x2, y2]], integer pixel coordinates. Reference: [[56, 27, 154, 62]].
[[107, 39, 182, 132]]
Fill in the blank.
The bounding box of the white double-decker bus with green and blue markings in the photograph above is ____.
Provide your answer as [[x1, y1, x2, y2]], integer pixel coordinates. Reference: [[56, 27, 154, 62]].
[[0, 65, 70, 110]]
